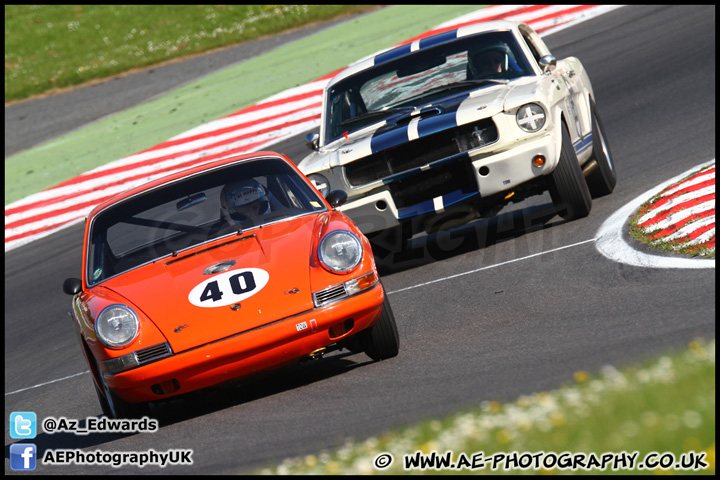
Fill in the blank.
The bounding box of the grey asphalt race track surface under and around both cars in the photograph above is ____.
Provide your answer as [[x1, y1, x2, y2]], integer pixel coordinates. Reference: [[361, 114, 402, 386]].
[[5, 6, 715, 474]]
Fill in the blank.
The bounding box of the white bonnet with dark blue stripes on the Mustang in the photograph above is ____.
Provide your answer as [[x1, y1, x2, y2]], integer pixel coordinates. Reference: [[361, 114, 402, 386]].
[[320, 84, 514, 167]]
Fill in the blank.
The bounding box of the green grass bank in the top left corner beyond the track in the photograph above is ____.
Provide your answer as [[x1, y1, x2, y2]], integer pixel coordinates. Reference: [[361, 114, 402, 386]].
[[5, 5, 375, 103]]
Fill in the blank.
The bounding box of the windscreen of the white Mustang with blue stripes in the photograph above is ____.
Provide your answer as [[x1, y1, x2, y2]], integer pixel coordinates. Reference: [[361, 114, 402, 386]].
[[324, 32, 533, 144]]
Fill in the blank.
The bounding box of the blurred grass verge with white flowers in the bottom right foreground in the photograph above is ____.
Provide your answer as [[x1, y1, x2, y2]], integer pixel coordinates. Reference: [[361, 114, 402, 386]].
[[254, 339, 715, 475]]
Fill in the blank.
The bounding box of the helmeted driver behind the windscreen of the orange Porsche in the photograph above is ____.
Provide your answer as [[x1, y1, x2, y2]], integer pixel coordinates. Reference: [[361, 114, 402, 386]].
[[220, 179, 270, 225]]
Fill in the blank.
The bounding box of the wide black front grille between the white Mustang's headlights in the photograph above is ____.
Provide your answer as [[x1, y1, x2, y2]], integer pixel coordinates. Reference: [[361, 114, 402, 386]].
[[345, 118, 498, 187]]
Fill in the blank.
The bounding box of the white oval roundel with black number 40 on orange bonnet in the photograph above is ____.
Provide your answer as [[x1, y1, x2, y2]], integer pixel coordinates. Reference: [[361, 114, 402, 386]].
[[188, 268, 270, 307]]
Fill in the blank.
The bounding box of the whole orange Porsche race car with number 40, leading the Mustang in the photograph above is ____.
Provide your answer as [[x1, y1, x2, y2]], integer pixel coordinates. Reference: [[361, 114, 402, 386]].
[[63, 152, 398, 418]]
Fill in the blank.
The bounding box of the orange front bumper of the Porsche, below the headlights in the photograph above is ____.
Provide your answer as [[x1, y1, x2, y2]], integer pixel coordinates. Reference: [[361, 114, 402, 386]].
[[105, 283, 384, 403]]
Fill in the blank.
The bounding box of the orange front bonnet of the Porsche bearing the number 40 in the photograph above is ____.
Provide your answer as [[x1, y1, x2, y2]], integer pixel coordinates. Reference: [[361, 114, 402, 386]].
[[103, 215, 317, 353]]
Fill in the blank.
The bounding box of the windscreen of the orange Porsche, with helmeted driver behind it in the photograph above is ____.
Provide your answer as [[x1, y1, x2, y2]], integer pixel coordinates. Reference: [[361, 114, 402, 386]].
[[86, 158, 326, 285]]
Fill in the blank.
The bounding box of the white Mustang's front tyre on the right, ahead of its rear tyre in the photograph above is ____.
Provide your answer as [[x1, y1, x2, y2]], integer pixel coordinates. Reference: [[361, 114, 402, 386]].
[[549, 123, 592, 221]]
